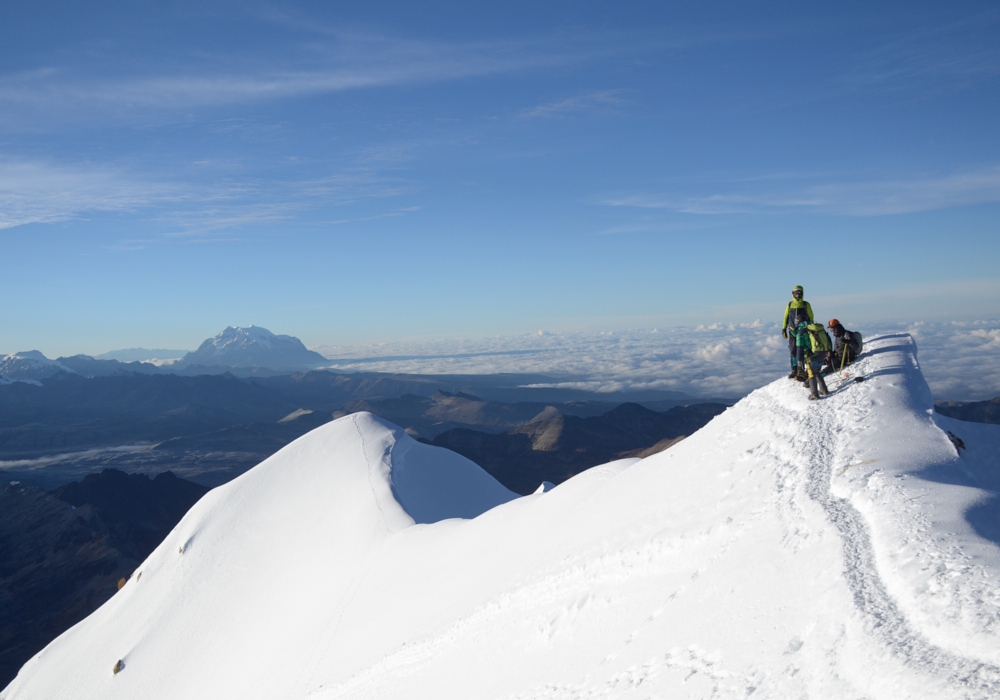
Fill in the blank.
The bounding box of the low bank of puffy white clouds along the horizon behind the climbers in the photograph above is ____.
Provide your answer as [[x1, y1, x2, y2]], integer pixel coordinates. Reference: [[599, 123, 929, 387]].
[[314, 320, 1000, 400]]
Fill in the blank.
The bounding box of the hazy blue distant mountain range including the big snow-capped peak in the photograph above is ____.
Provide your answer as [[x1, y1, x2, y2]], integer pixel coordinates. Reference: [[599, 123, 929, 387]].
[[0, 326, 729, 488]]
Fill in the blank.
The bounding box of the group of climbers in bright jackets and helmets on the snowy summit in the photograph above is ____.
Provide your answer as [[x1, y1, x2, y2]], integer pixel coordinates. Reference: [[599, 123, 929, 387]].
[[781, 285, 862, 400]]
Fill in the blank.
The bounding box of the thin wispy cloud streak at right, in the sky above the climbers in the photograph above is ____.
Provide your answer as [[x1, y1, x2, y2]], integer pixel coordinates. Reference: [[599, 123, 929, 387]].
[[603, 166, 1000, 216]]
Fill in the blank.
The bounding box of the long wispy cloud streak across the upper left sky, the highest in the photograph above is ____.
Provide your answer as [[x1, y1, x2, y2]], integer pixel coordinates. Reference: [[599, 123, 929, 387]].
[[0, 33, 588, 127]]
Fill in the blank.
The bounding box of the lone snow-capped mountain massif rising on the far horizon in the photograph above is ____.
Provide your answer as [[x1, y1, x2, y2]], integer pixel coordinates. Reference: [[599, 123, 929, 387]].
[[176, 326, 327, 369]]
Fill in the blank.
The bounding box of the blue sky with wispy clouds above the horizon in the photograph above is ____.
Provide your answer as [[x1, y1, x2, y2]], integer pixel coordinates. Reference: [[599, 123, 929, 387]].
[[0, 2, 1000, 357]]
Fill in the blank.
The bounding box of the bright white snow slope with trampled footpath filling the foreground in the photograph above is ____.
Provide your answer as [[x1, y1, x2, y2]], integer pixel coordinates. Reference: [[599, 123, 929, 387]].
[[0, 335, 1000, 700]]
